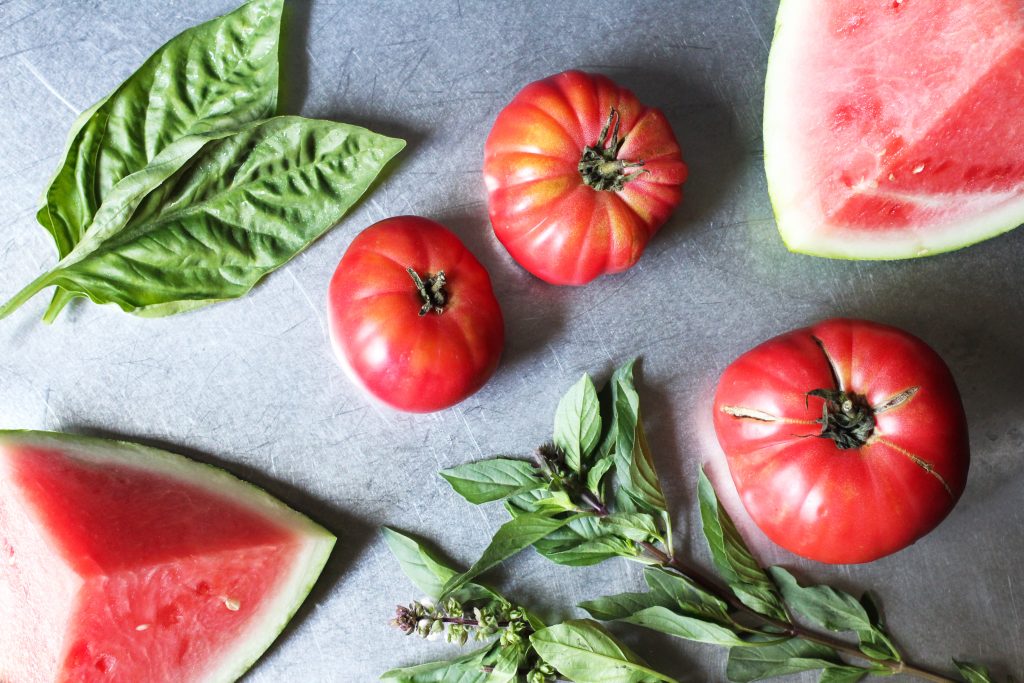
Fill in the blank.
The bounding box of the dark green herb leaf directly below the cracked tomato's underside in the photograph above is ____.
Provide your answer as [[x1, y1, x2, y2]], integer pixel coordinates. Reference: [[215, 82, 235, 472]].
[[768, 566, 899, 660]]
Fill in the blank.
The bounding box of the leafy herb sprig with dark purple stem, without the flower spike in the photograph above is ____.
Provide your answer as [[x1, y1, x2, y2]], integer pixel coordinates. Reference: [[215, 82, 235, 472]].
[[387, 361, 994, 683]]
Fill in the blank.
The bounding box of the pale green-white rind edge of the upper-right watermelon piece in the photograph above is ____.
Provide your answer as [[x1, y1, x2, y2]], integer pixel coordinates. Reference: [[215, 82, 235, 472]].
[[762, 0, 1024, 261]]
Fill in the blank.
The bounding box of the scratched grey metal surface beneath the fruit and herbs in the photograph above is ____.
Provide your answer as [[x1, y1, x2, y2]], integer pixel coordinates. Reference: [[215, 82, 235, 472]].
[[0, 0, 1024, 683]]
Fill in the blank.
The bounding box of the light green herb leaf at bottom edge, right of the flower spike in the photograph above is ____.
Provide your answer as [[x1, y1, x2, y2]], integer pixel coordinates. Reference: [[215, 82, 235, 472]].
[[529, 620, 675, 683]]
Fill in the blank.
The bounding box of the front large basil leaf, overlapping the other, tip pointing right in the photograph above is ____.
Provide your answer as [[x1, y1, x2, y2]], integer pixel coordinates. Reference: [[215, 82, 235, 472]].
[[0, 117, 404, 317]]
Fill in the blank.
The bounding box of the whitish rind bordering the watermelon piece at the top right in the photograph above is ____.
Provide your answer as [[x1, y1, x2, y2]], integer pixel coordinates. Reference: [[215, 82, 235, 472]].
[[762, 0, 1024, 261]]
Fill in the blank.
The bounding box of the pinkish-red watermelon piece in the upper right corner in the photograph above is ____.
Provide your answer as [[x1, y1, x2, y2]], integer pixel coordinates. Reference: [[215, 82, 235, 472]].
[[764, 0, 1024, 259]]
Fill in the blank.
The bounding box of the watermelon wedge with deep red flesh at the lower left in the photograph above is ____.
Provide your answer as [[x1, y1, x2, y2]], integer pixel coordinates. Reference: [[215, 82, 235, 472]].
[[0, 431, 335, 683]]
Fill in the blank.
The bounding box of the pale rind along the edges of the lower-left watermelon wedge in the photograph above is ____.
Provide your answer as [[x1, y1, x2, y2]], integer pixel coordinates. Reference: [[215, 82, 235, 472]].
[[0, 430, 337, 683]]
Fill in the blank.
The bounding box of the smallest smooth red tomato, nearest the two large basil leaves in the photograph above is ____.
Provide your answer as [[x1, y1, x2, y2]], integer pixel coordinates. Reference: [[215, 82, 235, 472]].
[[328, 216, 505, 413]]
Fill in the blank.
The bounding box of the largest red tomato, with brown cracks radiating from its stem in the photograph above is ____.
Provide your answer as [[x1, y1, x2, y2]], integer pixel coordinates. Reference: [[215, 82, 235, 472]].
[[715, 319, 970, 563]]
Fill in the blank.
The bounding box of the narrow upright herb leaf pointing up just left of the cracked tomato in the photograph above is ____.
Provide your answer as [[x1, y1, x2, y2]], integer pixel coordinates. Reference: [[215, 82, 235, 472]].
[[697, 468, 790, 622]]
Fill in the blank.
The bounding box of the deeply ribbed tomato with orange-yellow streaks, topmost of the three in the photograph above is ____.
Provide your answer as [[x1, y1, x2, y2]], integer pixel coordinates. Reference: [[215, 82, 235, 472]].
[[483, 71, 686, 285]]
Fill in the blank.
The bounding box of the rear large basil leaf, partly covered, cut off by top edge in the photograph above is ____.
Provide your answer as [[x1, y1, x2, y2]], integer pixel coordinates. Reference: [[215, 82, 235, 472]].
[[40, 0, 283, 258]]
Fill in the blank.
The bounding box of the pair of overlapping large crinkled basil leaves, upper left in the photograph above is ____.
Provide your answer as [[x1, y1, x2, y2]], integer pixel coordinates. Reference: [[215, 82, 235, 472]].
[[0, 0, 404, 321]]
